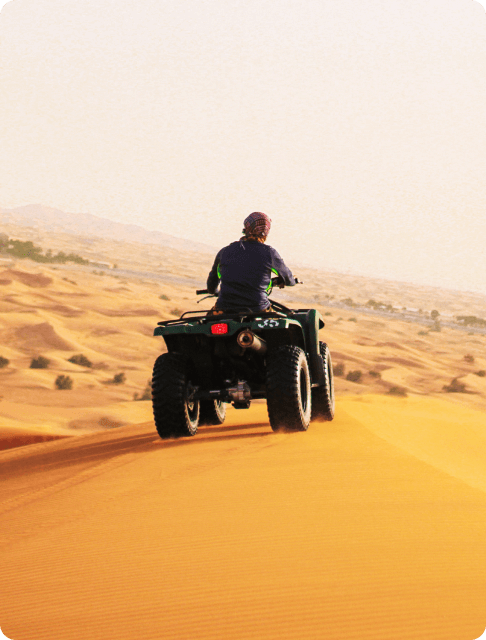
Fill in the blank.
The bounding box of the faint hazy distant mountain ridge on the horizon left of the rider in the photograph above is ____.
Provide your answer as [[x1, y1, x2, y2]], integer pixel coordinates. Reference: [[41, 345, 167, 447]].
[[0, 204, 215, 253]]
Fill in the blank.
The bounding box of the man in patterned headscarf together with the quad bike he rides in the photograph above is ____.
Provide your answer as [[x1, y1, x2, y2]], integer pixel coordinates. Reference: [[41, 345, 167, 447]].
[[152, 212, 334, 438]]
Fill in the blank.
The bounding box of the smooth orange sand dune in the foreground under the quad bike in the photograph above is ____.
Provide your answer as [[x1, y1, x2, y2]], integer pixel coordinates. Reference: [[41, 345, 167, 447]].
[[0, 396, 486, 640]]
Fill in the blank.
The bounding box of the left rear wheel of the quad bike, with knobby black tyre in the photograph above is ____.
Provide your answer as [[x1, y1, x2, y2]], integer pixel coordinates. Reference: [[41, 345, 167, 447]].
[[152, 353, 200, 439]]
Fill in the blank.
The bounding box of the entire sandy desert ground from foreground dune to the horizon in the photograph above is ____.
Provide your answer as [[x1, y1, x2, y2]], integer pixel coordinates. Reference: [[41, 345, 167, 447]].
[[0, 230, 486, 640]]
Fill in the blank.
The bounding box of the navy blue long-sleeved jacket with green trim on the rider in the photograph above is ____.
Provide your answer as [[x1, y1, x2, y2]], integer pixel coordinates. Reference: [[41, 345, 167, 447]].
[[207, 240, 295, 311]]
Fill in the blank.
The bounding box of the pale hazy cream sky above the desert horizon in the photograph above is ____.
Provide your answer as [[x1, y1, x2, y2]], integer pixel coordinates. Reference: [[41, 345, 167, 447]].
[[0, 0, 486, 293]]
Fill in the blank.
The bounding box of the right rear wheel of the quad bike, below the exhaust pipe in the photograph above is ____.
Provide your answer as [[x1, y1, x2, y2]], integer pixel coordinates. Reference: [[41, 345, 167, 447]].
[[266, 346, 312, 431]]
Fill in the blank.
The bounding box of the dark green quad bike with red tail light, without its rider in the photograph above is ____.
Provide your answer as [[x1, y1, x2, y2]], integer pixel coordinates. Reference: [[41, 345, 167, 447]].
[[152, 278, 334, 438]]
